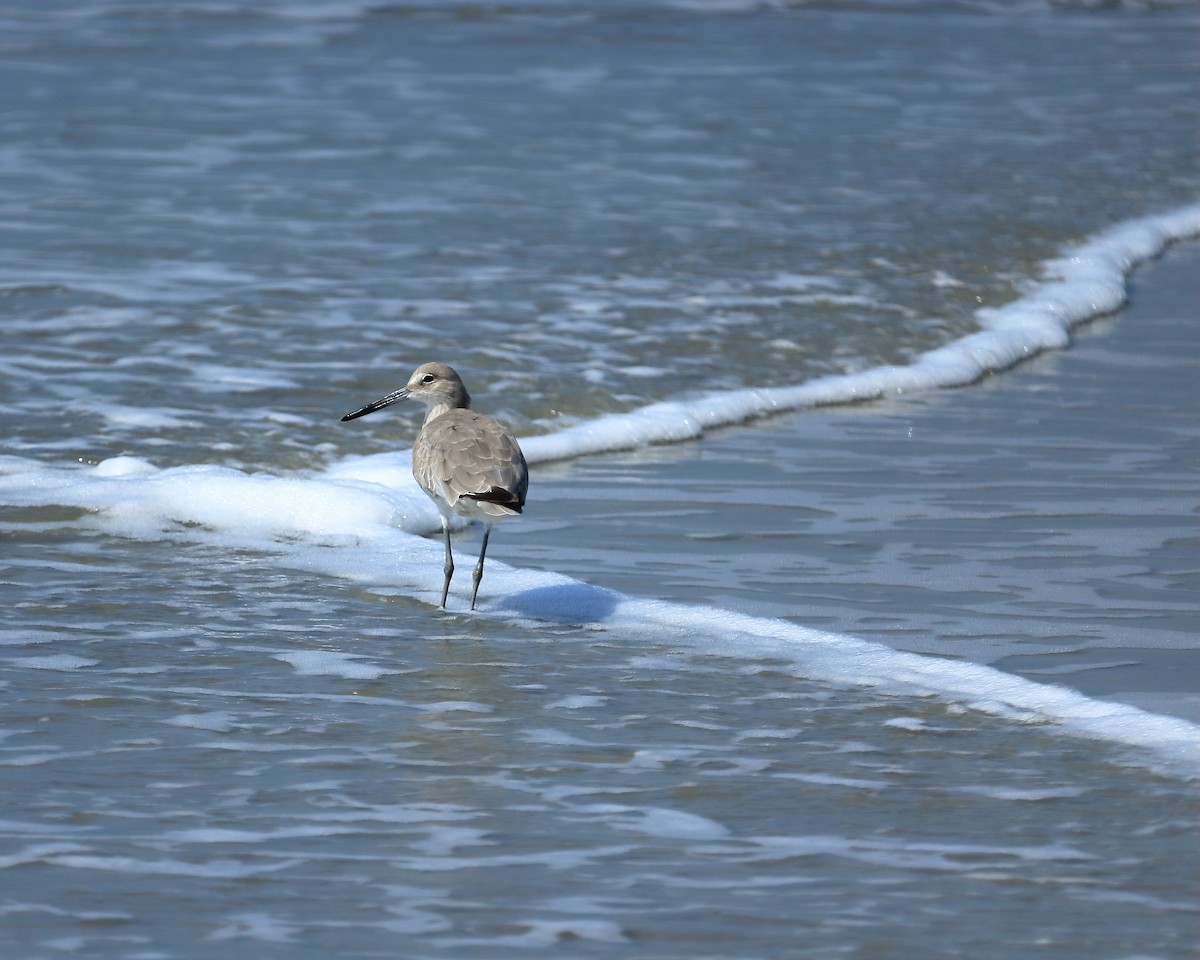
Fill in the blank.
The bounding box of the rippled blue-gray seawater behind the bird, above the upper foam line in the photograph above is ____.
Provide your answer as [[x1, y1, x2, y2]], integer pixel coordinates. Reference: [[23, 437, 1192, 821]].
[[0, 2, 1200, 469]]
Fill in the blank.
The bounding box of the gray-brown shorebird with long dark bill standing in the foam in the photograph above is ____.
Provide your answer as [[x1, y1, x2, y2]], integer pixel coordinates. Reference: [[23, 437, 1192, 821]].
[[342, 364, 529, 610]]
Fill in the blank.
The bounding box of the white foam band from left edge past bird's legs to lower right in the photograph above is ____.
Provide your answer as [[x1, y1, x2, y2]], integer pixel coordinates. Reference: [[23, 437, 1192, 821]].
[[9, 457, 1200, 778]]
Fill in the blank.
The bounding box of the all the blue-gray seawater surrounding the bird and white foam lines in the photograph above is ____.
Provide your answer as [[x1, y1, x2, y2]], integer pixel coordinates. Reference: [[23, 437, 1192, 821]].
[[0, 0, 1200, 960]]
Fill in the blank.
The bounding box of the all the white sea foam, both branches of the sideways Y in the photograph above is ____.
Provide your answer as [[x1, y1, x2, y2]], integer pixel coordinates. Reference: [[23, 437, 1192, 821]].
[[0, 205, 1200, 775]]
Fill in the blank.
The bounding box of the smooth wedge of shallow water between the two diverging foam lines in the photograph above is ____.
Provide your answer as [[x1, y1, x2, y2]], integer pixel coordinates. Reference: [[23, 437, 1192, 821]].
[[511, 245, 1200, 720]]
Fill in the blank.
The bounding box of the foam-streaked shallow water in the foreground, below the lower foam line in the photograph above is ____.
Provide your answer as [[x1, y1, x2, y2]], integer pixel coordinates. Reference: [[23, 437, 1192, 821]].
[[0, 540, 1195, 958]]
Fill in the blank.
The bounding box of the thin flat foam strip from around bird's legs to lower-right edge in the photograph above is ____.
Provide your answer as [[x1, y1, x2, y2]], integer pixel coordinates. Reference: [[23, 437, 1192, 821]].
[[281, 529, 1200, 779]]
